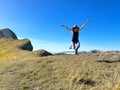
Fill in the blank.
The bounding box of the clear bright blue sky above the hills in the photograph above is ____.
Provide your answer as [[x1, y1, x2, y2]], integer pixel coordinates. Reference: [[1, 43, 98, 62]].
[[0, 0, 120, 52]]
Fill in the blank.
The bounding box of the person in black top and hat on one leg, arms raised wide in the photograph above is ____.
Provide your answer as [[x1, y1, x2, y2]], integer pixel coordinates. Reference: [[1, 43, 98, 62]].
[[61, 20, 89, 54]]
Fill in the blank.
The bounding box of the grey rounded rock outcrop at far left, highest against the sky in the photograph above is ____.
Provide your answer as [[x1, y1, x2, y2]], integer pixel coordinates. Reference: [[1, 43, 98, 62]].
[[0, 28, 18, 39]]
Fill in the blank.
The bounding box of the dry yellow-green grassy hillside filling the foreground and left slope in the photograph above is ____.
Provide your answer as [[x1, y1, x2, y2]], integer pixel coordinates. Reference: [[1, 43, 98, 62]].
[[0, 37, 120, 90]]
